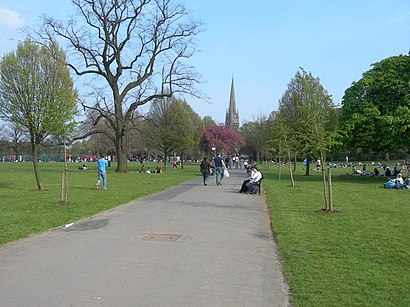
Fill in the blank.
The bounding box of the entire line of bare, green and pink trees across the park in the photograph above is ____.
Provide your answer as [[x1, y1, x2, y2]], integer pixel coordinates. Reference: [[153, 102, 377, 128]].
[[0, 0, 410, 200]]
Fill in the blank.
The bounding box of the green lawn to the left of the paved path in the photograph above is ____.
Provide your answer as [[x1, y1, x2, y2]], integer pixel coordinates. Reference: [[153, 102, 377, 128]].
[[0, 163, 200, 245]]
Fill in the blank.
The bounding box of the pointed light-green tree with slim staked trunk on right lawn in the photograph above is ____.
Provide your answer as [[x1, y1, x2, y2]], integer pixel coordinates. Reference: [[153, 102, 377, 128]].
[[279, 69, 337, 210]]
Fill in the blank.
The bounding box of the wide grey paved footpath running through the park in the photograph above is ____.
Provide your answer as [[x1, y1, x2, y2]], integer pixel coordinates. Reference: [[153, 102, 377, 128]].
[[0, 170, 290, 307]]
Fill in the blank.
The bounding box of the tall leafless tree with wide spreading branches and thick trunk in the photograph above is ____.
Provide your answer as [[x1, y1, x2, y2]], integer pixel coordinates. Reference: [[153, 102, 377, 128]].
[[36, 0, 201, 172]]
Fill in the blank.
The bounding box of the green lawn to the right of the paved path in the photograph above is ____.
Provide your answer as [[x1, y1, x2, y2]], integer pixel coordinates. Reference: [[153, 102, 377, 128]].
[[263, 166, 410, 307]]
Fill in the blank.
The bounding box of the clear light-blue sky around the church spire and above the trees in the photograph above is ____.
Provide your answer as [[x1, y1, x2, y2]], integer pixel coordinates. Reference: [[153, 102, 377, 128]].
[[0, 0, 410, 124]]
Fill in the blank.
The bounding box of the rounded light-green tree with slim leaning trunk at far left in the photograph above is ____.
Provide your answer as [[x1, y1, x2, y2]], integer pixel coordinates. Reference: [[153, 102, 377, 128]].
[[0, 39, 77, 190]]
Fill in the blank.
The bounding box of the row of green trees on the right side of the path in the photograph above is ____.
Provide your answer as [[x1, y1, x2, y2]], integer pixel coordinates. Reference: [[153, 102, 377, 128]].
[[241, 54, 410, 166]]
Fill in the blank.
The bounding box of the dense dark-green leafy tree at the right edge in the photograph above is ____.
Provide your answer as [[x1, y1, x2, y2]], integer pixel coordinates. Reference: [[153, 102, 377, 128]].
[[341, 55, 410, 154]]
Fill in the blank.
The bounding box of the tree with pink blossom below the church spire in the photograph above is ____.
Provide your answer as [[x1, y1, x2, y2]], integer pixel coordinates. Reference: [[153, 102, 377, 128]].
[[199, 125, 245, 153]]
